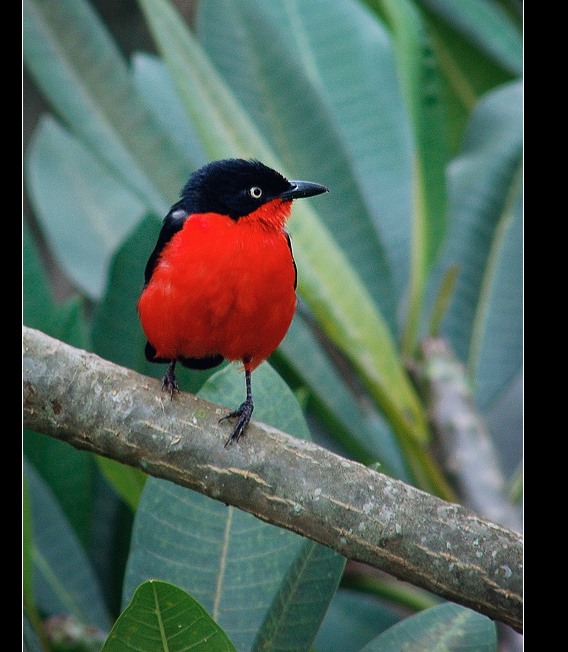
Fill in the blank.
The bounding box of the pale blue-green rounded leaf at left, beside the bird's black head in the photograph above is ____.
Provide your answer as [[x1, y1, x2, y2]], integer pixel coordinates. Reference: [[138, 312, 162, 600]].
[[26, 118, 144, 298]]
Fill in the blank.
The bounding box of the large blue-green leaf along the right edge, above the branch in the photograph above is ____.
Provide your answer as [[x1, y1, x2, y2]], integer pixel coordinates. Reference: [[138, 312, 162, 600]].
[[434, 82, 523, 408]]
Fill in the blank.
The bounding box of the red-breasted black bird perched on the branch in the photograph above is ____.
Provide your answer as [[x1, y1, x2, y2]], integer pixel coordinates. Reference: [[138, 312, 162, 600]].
[[137, 158, 329, 447]]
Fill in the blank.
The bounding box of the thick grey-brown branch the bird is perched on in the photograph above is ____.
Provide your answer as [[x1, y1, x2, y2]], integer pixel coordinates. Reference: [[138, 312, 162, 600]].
[[23, 327, 523, 631]]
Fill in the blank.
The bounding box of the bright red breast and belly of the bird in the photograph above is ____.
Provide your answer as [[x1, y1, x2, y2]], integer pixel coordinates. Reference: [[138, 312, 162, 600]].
[[138, 214, 296, 371]]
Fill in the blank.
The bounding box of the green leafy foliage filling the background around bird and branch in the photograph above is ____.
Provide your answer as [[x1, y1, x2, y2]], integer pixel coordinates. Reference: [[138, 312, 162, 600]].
[[23, 0, 523, 650]]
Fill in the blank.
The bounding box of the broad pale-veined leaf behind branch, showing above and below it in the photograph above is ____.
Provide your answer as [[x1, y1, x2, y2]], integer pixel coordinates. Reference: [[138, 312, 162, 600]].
[[123, 363, 343, 649]]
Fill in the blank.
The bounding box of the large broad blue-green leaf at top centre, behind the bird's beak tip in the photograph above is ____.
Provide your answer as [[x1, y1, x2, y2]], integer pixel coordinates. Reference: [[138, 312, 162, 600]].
[[197, 0, 412, 320]]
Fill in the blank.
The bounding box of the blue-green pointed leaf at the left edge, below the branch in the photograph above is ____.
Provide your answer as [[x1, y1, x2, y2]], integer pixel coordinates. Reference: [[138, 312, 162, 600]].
[[24, 460, 110, 631]]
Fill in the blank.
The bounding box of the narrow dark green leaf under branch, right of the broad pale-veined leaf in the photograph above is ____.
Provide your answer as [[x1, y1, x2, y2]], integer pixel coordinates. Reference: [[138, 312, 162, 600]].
[[252, 541, 345, 652]]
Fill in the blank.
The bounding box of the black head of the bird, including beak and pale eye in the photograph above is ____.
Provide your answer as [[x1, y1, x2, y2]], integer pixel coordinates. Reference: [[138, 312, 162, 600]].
[[180, 158, 328, 220]]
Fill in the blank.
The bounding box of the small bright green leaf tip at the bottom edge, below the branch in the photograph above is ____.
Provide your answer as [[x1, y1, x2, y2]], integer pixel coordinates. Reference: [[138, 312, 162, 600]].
[[102, 580, 236, 652]]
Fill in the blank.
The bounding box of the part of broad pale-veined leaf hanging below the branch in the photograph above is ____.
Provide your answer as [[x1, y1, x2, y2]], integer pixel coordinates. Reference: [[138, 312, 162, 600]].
[[123, 478, 302, 649]]
